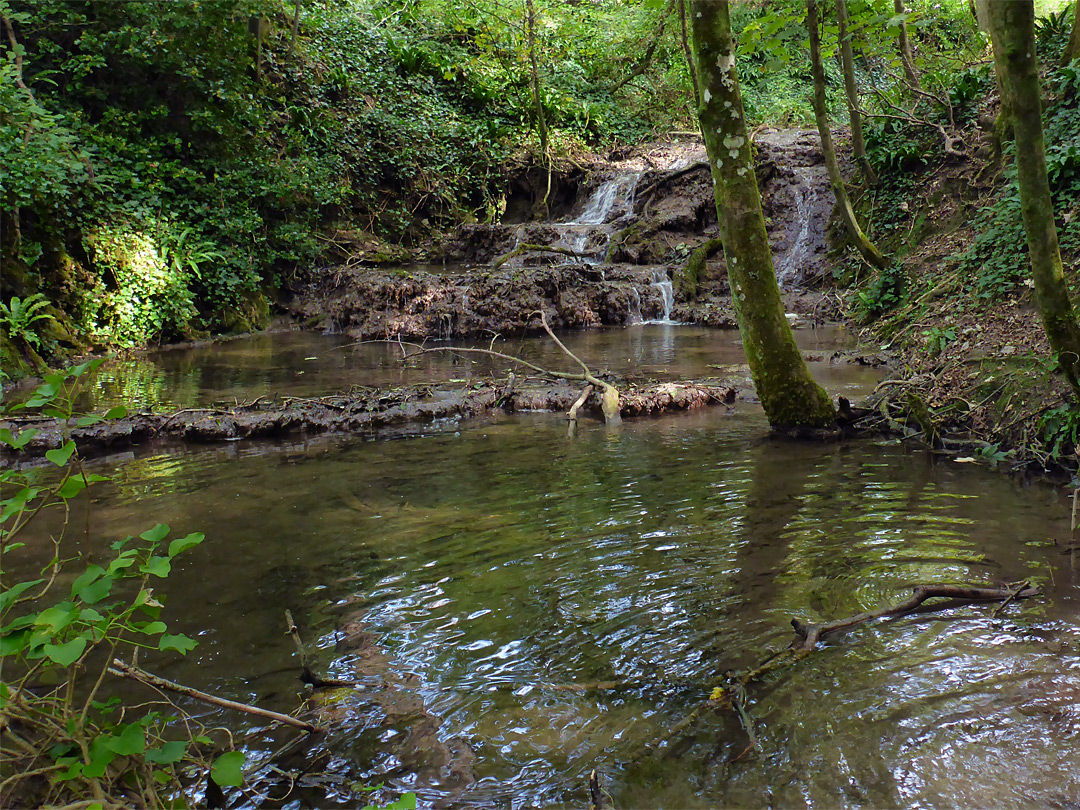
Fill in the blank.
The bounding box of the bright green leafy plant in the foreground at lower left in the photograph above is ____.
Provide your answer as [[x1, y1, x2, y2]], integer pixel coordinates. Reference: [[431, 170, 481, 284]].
[[0, 361, 244, 806]]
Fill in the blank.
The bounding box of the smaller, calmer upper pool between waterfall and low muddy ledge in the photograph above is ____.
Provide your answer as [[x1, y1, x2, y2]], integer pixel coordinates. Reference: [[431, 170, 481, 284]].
[[65, 324, 879, 410]]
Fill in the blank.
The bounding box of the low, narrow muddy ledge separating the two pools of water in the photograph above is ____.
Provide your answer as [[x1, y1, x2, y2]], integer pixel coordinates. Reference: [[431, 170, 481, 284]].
[[0, 381, 737, 462]]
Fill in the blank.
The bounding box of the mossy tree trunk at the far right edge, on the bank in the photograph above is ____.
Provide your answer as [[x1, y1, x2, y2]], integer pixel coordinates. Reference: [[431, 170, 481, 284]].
[[989, 0, 1080, 391]]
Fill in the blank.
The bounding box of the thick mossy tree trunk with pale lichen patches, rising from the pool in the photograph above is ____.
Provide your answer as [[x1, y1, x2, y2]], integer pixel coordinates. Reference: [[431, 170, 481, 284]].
[[687, 0, 836, 429]]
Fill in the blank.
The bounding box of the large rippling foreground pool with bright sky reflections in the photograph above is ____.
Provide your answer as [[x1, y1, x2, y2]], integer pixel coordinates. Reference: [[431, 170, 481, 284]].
[[12, 407, 1080, 808]]
